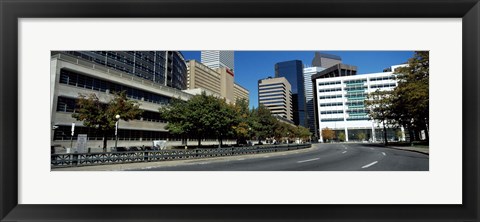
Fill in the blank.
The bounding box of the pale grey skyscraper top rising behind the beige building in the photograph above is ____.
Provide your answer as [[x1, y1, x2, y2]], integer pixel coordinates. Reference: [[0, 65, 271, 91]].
[[201, 51, 235, 70]]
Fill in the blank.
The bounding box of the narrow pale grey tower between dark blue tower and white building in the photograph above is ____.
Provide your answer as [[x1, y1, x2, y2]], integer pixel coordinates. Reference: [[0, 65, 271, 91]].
[[303, 67, 325, 135]]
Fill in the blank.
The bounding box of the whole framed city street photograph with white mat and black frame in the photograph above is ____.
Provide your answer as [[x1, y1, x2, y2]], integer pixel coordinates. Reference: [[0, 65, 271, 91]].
[[0, 0, 480, 221]]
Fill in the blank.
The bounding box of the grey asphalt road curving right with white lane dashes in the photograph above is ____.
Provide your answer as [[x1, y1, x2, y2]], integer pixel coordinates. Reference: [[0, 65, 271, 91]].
[[130, 143, 429, 171]]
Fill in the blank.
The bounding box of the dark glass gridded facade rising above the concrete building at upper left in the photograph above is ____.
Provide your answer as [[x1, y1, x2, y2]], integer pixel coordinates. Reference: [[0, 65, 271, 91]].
[[54, 51, 187, 90]]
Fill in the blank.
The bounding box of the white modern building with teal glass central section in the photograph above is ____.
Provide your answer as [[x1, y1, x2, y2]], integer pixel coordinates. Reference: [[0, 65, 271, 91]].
[[312, 66, 404, 141]]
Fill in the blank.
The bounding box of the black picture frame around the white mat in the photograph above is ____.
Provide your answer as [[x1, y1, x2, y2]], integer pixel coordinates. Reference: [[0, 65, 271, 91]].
[[0, 0, 480, 221]]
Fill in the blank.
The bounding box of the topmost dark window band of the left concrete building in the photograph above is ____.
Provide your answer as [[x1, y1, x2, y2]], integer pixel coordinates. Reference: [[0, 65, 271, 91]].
[[60, 69, 170, 104]]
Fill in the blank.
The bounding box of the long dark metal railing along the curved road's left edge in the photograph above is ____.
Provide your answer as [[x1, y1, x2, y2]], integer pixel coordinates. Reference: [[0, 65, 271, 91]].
[[51, 143, 311, 168]]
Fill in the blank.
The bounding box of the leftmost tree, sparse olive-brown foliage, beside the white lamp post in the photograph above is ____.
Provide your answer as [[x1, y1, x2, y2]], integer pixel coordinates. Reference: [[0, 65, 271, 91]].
[[72, 92, 143, 152]]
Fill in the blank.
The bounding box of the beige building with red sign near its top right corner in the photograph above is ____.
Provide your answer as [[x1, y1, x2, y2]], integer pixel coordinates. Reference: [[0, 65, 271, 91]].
[[187, 60, 249, 103]]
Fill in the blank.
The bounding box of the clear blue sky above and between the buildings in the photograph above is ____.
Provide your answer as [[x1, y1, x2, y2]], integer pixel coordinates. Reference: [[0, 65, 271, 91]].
[[182, 51, 413, 107]]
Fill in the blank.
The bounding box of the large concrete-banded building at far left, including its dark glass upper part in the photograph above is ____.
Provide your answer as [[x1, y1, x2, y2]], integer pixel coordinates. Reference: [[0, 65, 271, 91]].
[[50, 52, 230, 152]]
